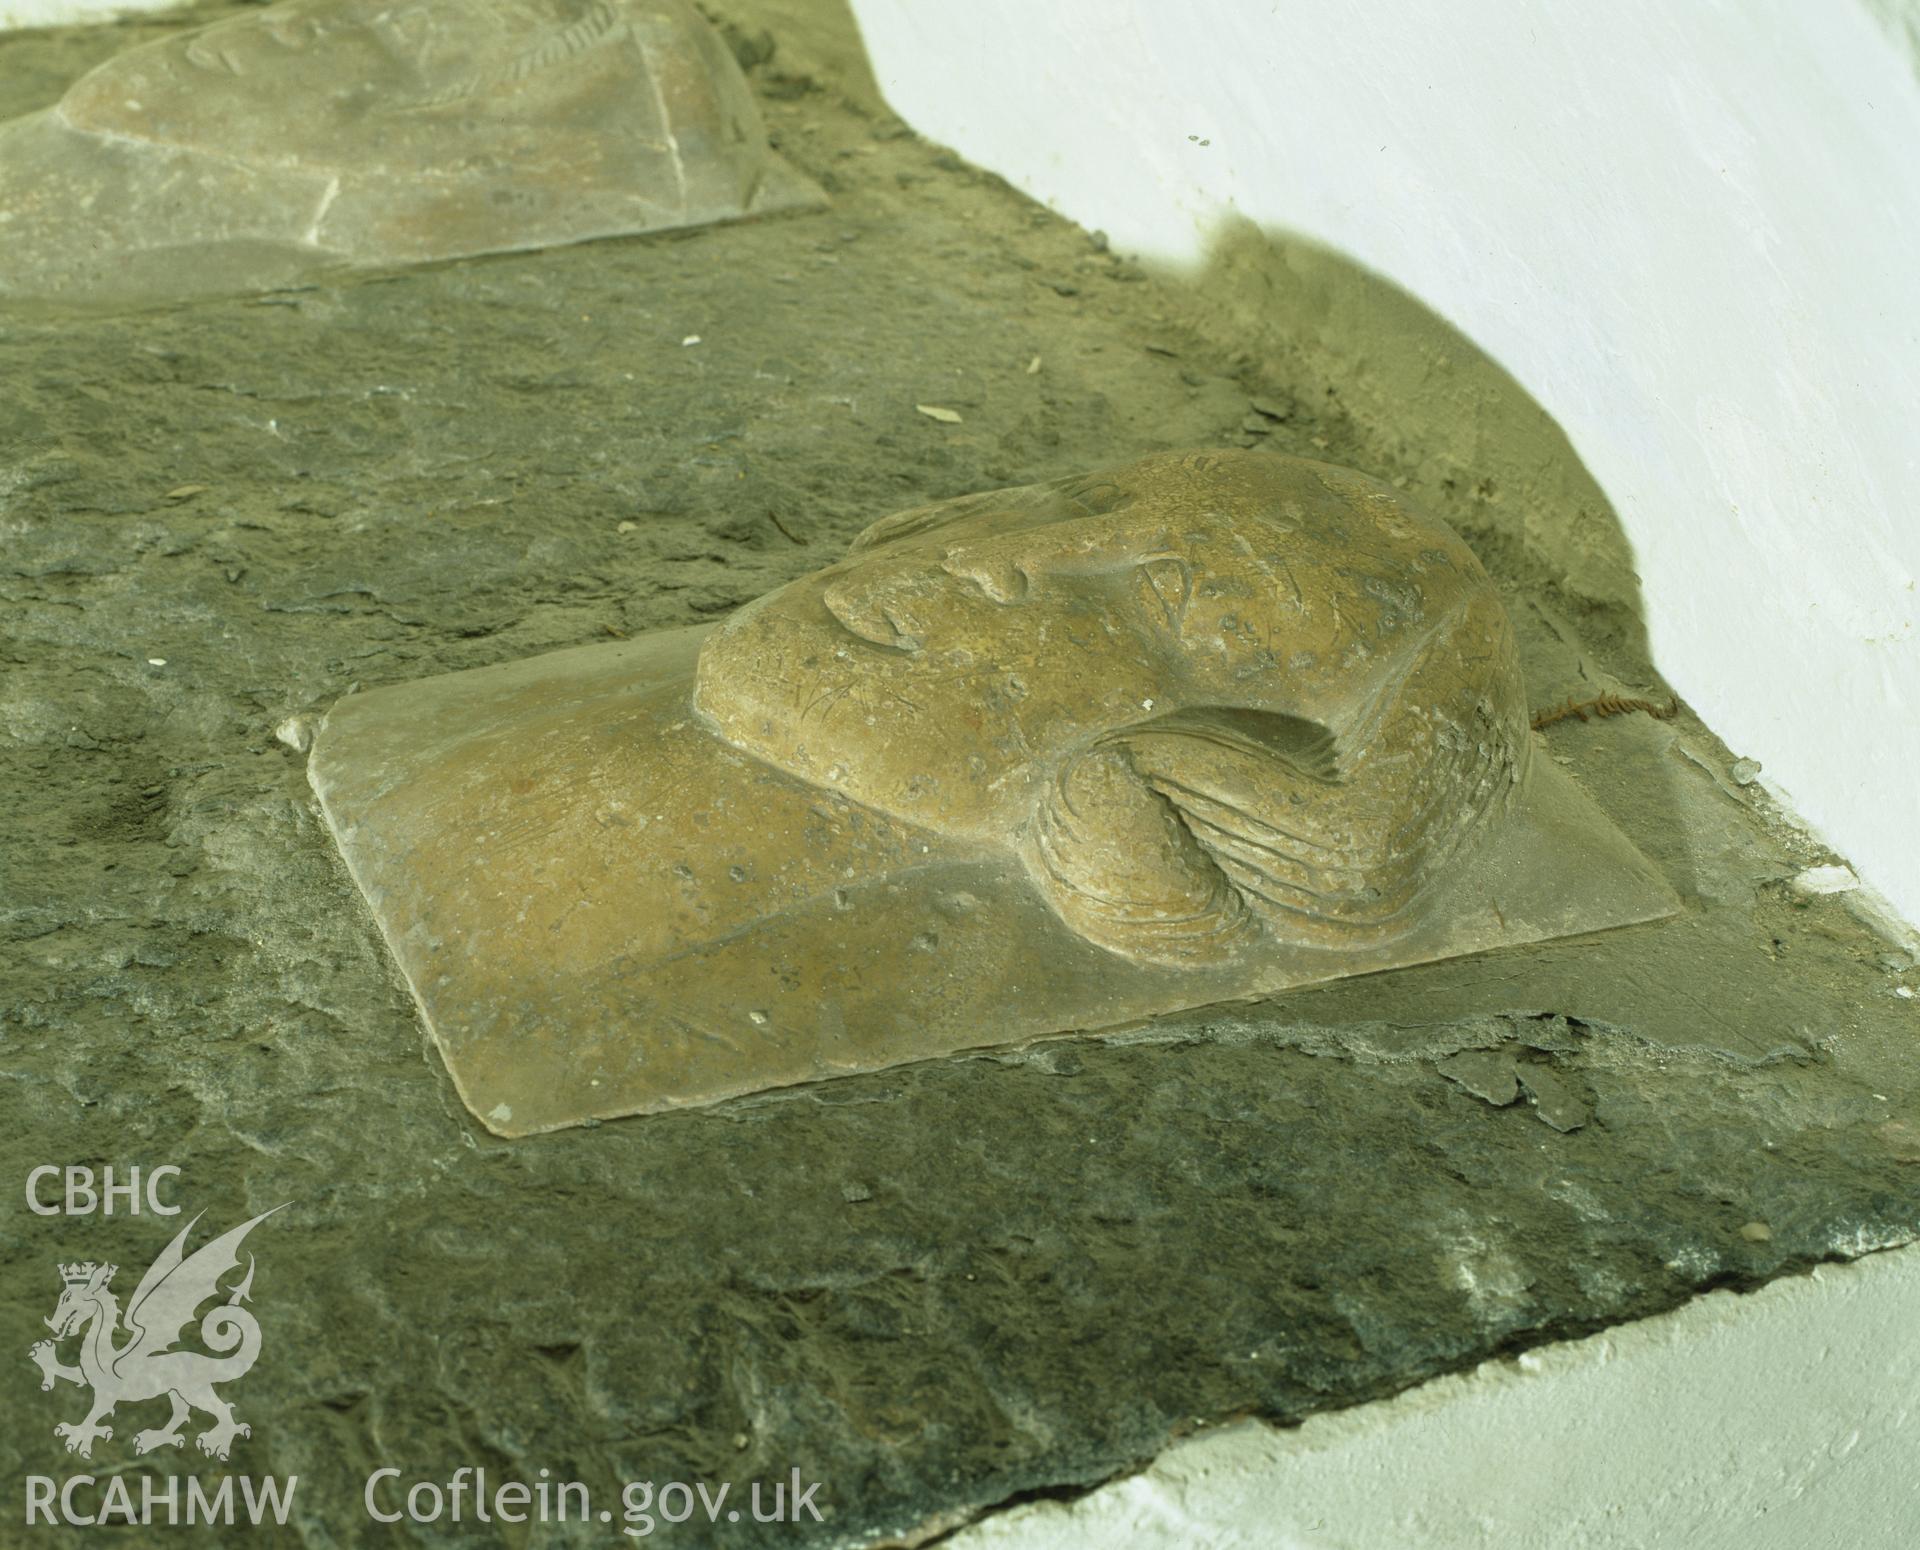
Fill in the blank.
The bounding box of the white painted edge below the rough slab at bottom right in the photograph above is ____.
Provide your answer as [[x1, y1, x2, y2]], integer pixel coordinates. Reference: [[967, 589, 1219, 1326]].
[[945, 1245, 1920, 1550]]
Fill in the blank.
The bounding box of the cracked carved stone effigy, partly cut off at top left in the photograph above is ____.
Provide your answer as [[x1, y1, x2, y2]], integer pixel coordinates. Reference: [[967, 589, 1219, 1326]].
[[0, 0, 820, 302]]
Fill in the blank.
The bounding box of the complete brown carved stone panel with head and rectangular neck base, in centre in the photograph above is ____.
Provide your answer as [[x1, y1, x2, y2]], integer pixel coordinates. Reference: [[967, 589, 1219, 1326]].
[[309, 451, 1676, 1135]]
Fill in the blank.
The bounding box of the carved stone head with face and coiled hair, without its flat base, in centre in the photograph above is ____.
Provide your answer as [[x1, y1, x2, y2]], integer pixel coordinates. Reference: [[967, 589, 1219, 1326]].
[[693, 453, 1530, 964]]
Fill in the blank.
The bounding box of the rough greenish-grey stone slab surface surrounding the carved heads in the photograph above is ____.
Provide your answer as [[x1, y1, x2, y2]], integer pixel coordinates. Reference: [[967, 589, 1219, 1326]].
[[0, 4, 1920, 1546]]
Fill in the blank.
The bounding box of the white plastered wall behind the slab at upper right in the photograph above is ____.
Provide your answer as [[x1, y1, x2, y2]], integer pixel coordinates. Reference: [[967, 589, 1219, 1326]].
[[852, 0, 1920, 920]]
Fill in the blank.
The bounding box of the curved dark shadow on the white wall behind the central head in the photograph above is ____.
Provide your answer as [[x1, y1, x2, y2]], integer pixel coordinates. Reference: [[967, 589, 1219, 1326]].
[[1160, 219, 1695, 897]]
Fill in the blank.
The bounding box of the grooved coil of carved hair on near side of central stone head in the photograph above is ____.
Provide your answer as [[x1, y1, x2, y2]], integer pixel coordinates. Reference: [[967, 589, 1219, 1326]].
[[1027, 587, 1528, 964]]
